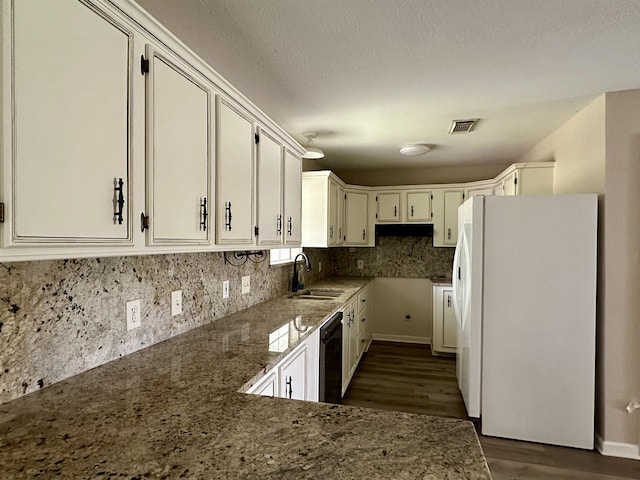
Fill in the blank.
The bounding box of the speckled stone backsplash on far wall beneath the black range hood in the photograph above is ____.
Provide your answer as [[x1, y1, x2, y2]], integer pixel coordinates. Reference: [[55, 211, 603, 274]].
[[330, 237, 455, 278]]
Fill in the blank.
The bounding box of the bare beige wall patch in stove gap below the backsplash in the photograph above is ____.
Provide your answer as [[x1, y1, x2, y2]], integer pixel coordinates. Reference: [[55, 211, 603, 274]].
[[371, 277, 433, 343]]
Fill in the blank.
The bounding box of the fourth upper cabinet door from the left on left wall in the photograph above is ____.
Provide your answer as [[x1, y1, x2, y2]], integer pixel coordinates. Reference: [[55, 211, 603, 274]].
[[256, 131, 283, 245]]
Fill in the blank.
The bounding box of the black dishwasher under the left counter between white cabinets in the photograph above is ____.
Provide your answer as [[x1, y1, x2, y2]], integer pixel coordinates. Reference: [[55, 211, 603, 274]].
[[318, 312, 342, 403]]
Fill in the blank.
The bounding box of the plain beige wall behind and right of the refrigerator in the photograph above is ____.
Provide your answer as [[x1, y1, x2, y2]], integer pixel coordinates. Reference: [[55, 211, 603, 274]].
[[519, 90, 640, 456]]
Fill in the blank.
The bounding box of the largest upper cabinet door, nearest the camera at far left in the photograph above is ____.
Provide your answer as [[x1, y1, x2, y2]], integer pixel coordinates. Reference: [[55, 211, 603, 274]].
[[8, 1, 133, 244]]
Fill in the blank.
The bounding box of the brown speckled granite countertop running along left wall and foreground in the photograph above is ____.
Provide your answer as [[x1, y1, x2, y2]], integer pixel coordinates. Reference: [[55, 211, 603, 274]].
[[0, 278, 491, 480]]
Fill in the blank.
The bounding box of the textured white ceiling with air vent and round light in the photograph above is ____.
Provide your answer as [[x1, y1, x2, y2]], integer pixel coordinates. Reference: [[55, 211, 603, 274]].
[[138, 0, 640, 174]]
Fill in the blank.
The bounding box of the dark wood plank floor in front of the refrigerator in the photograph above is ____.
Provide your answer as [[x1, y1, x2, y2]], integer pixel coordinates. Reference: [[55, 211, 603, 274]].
[[343, 342, 640, 480]]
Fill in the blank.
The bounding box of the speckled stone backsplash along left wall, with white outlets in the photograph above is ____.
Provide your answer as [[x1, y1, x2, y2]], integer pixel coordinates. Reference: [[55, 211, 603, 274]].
[[0, 252, 329, 403]]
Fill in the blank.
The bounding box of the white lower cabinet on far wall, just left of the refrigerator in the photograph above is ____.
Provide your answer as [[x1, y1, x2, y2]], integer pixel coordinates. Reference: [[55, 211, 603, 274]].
[[431, 285, 458, 355]]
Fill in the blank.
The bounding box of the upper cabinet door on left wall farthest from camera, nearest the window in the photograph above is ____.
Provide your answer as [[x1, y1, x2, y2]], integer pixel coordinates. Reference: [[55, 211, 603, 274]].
[[284, 150, 302, 245]]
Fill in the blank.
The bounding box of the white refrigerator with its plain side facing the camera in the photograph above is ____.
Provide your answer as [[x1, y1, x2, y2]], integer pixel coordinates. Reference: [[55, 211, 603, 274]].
[[453, 195, 597, 449]]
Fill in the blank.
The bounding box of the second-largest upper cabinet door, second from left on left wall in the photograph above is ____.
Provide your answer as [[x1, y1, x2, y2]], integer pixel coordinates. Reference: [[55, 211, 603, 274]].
[[146, 45, 210, 245]]
